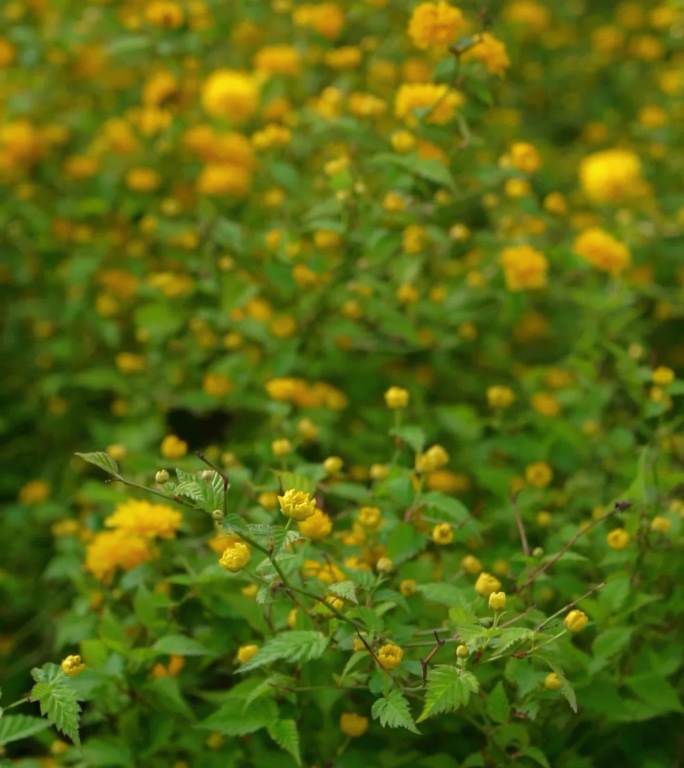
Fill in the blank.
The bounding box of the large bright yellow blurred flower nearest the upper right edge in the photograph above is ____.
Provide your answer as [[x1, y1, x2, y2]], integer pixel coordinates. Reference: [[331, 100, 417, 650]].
[[579, 149, 644, 203]]
